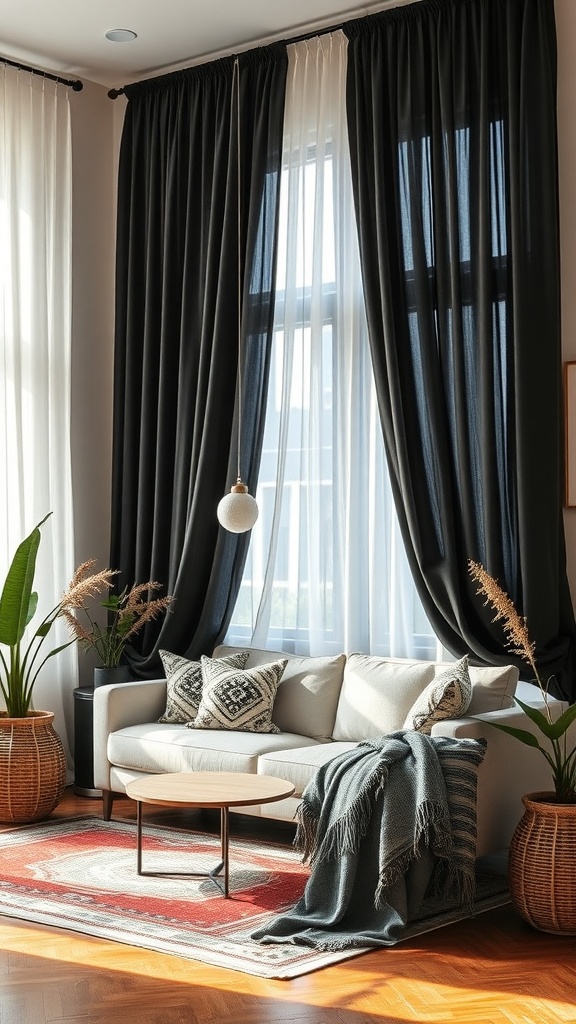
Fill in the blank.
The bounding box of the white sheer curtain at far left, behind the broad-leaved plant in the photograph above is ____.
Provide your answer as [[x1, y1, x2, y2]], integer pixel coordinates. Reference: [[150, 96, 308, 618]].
[[0, 66, 77, 746]]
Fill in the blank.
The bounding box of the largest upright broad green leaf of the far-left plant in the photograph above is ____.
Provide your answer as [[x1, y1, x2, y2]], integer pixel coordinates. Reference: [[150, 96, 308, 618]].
[[0, 512, 51, 647]]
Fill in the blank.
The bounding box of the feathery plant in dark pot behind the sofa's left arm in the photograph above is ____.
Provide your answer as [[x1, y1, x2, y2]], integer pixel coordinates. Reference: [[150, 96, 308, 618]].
[[64, 573, 172, 686]]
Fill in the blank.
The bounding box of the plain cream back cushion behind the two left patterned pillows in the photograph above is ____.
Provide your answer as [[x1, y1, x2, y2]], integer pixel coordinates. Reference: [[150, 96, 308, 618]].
[[214, 645, 346, 740]]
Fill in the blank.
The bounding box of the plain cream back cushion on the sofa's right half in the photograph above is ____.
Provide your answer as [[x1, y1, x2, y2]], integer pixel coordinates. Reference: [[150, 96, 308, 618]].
[[332, 654, 435, 740]]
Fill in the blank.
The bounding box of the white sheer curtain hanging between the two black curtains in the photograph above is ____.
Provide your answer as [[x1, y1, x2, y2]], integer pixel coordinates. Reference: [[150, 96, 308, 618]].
[[228, 32, 439, 657]]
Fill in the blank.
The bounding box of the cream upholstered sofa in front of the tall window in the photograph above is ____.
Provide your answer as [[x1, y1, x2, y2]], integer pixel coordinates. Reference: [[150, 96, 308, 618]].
[[93, 647, 565, 856]]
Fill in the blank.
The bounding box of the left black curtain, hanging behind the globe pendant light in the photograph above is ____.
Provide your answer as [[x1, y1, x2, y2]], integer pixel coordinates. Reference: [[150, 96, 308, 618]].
[[111, 44, 287, 676]]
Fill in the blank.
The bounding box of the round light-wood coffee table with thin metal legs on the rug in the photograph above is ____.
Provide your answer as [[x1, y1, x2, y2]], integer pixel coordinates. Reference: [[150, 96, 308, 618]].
[[126, 771, 294, 897]]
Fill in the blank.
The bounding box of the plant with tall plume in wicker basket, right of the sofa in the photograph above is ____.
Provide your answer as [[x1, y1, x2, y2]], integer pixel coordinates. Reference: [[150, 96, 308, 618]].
[[468, 560, 576, 935]]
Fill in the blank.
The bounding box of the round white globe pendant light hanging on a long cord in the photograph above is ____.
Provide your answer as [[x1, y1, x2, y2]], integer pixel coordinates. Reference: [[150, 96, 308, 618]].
[[216, 57, 258, 534]]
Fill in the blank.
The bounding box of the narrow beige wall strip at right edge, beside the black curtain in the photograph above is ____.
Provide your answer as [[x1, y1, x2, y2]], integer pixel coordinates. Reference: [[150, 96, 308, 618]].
[[554, 0, 576, 601]]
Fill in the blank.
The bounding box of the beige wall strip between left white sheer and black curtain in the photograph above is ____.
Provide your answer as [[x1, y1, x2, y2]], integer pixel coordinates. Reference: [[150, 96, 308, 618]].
[[70, 81, 120, 685]]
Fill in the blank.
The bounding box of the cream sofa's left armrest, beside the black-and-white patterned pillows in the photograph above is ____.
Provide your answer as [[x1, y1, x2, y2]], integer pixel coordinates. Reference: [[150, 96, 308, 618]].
[[93, 679, 166, 790]]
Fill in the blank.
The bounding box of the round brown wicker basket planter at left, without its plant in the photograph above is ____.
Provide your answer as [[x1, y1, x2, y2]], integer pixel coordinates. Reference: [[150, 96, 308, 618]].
[[0, 711, 66, 823]]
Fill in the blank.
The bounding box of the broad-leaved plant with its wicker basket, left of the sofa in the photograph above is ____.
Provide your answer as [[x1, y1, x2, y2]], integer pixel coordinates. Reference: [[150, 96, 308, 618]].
[[0, 516, 112, 822]]
